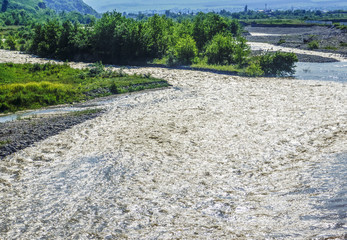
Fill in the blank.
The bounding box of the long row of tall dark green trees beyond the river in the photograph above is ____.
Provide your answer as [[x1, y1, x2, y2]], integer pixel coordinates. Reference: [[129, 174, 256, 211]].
[[30, 12, 248, 64]]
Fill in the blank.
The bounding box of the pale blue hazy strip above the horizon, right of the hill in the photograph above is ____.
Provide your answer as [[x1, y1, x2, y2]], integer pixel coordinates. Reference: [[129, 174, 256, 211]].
[[84, 0, 347, 12]]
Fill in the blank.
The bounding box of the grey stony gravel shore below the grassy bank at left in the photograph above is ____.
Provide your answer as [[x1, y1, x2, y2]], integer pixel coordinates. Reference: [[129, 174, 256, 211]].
[[0, 110, 104, 159]]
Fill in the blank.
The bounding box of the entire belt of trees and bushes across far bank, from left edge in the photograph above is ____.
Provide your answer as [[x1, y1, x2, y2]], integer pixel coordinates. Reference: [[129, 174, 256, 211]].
[[0, 0, 304, 76]]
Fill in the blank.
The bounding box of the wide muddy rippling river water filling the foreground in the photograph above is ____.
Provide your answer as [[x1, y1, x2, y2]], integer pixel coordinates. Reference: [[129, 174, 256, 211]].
[[0, 50, 347, 239]]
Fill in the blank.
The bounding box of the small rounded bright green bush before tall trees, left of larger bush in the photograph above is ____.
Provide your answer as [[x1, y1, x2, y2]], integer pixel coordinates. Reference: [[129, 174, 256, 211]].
[[174, 35, 198, 65]]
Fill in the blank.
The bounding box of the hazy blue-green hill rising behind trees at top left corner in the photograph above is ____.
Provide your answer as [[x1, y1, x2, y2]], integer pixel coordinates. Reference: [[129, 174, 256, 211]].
[[0, 0, 100, 17]]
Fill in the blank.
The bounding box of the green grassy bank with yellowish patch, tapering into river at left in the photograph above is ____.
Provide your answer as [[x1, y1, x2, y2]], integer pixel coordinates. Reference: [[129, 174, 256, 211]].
[[0, 63, 168, 113]]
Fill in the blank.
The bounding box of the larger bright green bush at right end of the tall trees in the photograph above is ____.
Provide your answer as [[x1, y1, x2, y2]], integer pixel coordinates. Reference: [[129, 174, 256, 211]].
[[205, 33, 250, 65]]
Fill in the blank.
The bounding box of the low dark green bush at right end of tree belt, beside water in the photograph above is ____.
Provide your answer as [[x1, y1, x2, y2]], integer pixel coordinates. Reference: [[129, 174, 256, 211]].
[[259, 52, 298, 76]]
